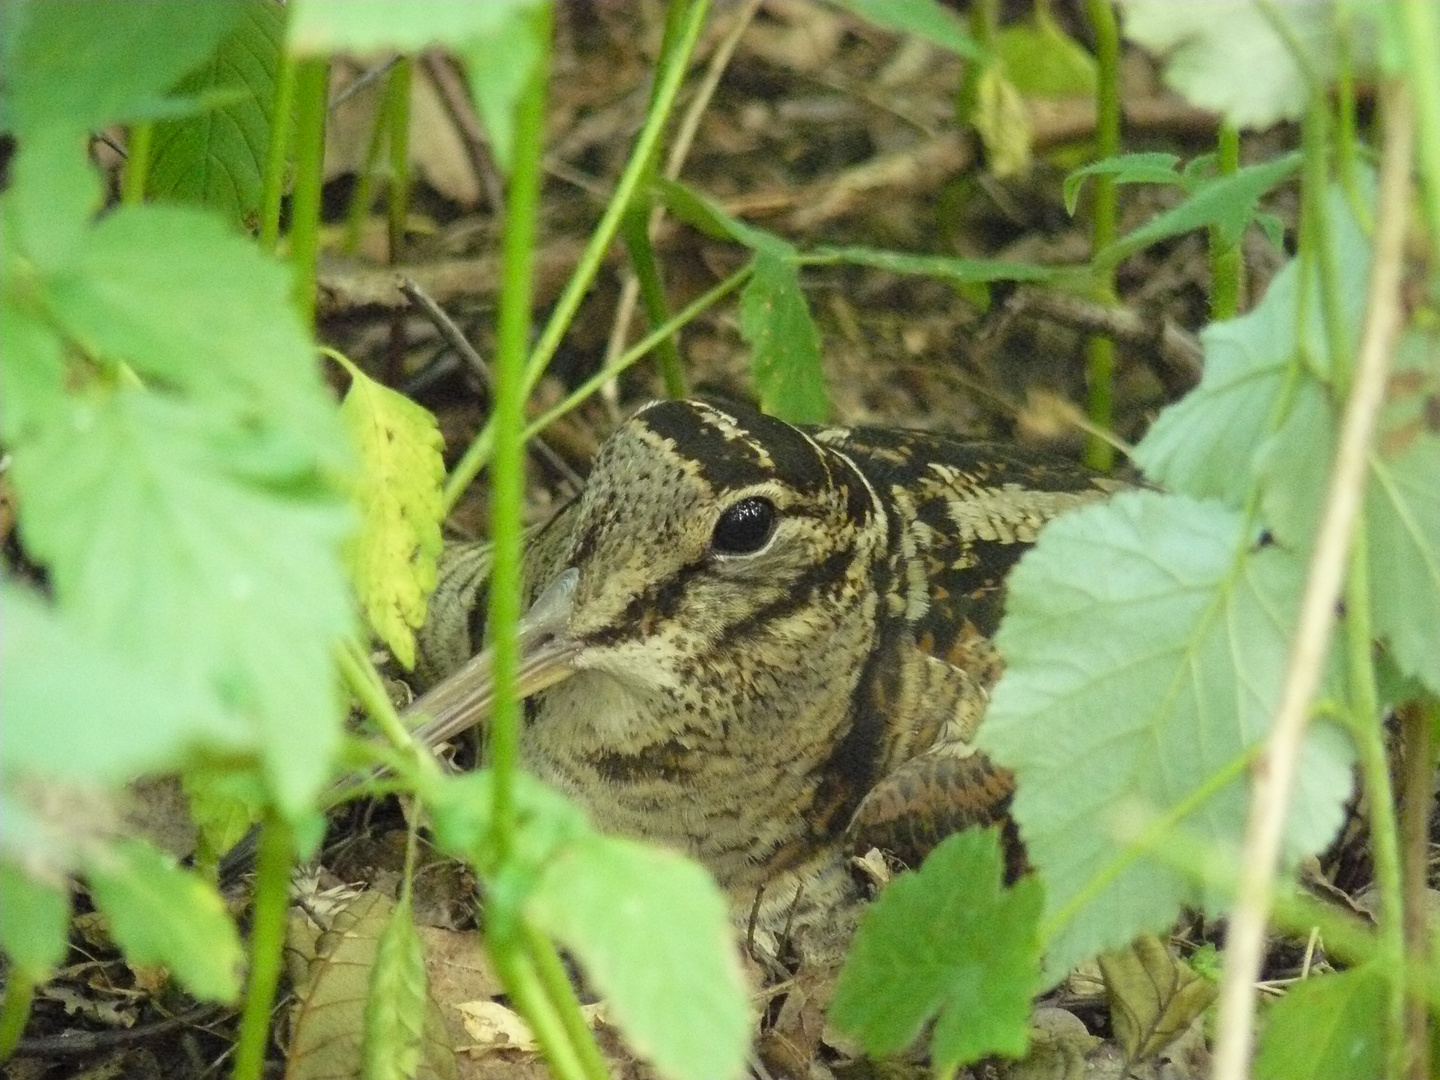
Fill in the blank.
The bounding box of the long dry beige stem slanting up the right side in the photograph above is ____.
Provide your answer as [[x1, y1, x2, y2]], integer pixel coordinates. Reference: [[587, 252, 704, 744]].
[[1214, 82, 1411, 1080]]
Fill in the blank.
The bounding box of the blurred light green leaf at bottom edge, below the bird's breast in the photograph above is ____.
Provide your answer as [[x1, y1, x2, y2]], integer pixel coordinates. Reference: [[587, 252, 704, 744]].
[[526, 834, 752, 1080]]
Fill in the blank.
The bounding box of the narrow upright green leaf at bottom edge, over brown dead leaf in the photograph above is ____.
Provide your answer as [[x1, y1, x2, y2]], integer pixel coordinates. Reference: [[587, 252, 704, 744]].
[[360, 903, 431, 1080]]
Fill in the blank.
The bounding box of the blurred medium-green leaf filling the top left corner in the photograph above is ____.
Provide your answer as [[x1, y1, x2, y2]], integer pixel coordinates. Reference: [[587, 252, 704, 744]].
[[0, 0, 242, 143]]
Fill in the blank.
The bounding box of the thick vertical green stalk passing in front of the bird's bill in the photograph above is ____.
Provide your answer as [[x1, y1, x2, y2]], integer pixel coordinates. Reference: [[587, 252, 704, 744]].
[[490, 4, 552, 864]]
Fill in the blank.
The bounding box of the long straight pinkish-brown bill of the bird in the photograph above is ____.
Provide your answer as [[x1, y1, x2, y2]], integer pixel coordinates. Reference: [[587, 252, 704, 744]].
[[403, 569, 579, 746]]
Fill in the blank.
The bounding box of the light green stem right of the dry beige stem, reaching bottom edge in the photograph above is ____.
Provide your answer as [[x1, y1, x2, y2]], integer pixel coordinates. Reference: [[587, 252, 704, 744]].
[[1345, 518, 1405, 1080]]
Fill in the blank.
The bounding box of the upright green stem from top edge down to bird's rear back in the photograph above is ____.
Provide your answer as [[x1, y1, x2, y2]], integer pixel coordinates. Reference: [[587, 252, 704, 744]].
[[1084, 0, 1120, 471]]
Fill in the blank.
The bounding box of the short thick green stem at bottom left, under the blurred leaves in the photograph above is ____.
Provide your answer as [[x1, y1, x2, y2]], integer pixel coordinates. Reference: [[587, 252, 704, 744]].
[[230, 812, 294, 1080]]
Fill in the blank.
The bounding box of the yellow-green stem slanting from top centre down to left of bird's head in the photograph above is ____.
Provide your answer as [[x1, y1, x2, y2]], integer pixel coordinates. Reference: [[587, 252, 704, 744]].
[[445, 0, 710, 510]]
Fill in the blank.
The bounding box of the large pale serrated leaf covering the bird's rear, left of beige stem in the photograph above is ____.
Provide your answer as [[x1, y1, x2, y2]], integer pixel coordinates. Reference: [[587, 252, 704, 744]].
[[978, 491, 1352, 975]]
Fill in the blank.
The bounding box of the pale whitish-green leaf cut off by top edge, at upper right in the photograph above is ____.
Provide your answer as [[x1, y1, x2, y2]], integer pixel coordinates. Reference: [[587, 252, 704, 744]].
[[1120, 0, 1374, 128]]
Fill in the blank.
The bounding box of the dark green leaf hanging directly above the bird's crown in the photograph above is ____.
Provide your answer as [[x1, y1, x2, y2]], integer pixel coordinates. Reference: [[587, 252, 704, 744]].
[[740, 251, 829, 423]]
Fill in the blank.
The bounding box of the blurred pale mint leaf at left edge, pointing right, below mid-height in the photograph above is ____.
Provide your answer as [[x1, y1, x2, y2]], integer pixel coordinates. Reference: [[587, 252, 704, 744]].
[[0, 579, 234, 783]]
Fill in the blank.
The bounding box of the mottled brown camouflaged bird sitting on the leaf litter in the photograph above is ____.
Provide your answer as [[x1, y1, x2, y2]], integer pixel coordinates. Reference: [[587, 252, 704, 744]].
[[415, 400, 1115, 933]]
